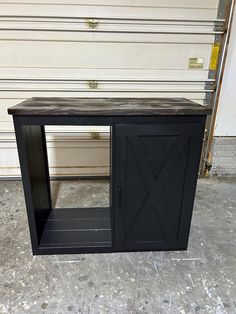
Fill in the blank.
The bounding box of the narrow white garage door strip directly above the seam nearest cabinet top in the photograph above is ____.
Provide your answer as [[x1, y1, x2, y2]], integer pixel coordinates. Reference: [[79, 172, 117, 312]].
[[0, 66, 208, 81]]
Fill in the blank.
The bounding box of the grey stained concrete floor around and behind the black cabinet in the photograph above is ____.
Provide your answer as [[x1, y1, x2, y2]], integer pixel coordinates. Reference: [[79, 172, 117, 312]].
[[0, 179, 236, 314]]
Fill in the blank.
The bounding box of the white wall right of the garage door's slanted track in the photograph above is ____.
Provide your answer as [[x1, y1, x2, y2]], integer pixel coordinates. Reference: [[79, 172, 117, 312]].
[[214, 5, 236, 136]]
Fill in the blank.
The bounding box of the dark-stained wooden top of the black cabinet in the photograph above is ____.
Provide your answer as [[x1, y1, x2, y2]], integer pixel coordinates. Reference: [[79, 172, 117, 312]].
[[8, 97, 211, 116]]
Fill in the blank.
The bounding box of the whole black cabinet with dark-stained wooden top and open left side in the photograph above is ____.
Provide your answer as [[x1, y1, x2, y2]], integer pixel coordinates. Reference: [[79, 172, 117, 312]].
[[8, 98, 210, 254]]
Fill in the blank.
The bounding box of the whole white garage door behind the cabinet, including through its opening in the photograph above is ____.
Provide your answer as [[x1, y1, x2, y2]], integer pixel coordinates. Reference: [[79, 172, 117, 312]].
[[0, 0, 229, 177]]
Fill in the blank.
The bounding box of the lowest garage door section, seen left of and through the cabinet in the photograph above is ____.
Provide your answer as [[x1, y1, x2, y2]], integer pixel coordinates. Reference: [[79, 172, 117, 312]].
[[0, 133, 109, 177]]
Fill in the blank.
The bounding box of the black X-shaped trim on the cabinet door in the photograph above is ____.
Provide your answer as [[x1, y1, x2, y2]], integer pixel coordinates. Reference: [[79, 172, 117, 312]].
[[125, 135, 189, 242]]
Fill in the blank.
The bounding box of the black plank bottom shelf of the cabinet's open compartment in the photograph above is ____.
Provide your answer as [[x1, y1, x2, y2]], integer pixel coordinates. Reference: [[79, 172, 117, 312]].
[[39, 208, 112, 252]]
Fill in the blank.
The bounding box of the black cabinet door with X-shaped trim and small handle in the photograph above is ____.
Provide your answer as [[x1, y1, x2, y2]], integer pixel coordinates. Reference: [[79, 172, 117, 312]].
[[113, 122, 204, 251]]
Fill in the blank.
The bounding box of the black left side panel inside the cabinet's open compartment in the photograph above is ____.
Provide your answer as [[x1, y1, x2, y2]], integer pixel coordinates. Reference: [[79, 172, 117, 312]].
[[14, 119, 51, 252]]
